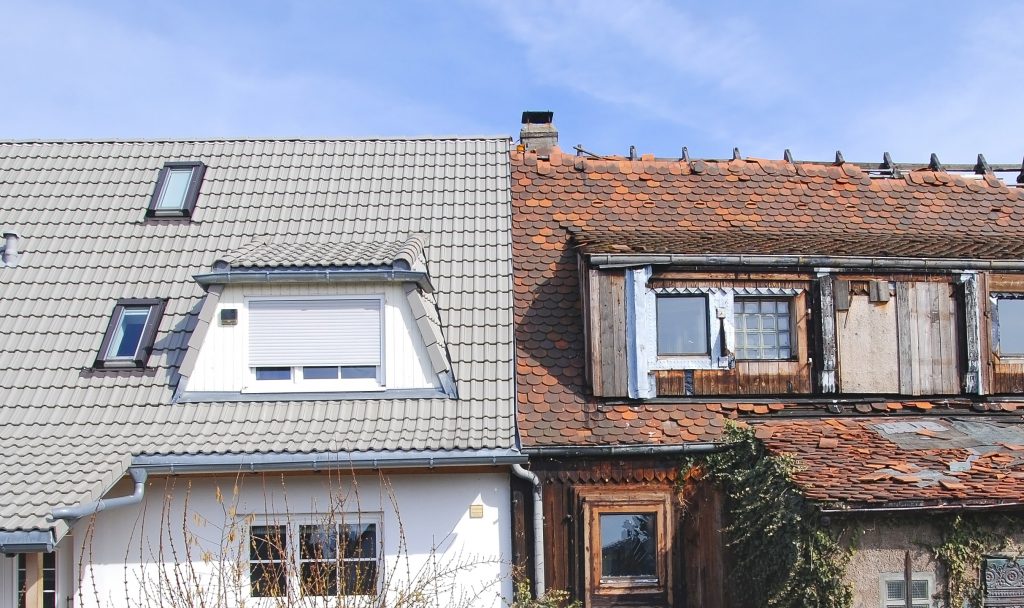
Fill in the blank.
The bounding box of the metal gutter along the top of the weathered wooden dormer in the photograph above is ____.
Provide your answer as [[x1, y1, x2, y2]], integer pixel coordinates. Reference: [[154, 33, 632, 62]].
[[588, 254, 1024, 271]]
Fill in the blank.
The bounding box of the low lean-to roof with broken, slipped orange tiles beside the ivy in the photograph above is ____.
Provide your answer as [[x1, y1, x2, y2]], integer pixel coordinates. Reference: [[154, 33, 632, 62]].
[[755, 418, 1024, 508]]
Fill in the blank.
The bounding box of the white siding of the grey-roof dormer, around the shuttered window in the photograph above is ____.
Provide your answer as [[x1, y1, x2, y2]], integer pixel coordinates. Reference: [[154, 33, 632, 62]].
[[188, 284, 440, 393]]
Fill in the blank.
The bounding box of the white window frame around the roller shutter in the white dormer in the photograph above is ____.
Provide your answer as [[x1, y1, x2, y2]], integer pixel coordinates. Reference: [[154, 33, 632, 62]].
[[242, 294, 387, 393]]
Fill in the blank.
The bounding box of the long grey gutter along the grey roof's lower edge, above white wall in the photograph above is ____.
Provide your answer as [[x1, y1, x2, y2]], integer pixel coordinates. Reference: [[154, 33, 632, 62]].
[[132, 449, 526, 475]]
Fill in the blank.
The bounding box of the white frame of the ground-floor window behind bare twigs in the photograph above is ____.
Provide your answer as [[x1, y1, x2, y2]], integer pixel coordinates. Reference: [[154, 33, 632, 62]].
[[243, 511, 386, 606]]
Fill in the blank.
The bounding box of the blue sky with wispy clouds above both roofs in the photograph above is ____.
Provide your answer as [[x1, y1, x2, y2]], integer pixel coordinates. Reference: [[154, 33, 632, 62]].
[[0, 0, 1024, 163]]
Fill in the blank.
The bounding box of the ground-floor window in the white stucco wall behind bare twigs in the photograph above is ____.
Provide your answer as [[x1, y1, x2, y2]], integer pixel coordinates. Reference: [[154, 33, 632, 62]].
[[249, 517, 380, 598]]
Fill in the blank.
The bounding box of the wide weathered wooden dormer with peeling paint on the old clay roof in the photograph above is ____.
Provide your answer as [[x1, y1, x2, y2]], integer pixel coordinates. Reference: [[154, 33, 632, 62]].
[[572, 228, 1024, 398]]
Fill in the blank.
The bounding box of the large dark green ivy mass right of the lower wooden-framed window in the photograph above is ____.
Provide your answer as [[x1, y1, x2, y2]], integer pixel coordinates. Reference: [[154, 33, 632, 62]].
[[683, 425, 853, 608]]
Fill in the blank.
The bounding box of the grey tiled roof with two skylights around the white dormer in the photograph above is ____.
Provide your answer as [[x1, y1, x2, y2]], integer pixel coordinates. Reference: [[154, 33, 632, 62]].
[[0, 138, 515, 530]]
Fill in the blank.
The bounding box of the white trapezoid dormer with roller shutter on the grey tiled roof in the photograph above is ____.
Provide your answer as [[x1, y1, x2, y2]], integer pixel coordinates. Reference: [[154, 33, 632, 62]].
[[179, 234, 456, 401]]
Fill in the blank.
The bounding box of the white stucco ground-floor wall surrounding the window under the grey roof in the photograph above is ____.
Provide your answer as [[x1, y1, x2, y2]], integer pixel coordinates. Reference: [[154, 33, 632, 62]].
[[62, 469, 512, 608]]
